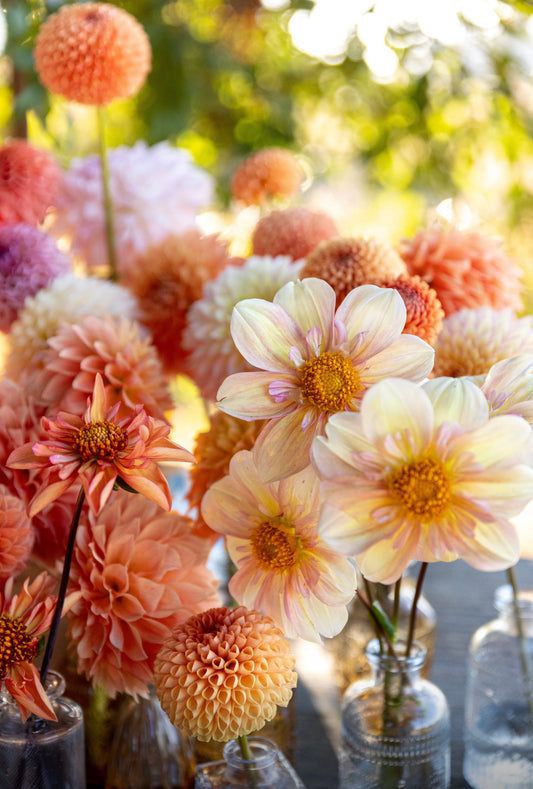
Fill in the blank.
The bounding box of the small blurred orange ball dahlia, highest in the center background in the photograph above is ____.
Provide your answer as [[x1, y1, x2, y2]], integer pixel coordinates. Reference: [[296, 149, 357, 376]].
[[231, 148, 302, 205]]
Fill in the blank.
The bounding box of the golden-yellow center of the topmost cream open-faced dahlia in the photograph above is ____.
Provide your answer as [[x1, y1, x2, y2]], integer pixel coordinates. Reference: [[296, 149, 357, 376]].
[[300, 353, 363, 412]]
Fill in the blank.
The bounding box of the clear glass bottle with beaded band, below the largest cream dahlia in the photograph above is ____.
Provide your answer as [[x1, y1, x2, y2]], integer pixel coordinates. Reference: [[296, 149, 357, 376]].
[[339, 639, 450, 789]]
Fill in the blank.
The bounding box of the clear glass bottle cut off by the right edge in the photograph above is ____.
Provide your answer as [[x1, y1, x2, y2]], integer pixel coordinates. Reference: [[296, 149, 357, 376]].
[[463, 586, 533, 789]]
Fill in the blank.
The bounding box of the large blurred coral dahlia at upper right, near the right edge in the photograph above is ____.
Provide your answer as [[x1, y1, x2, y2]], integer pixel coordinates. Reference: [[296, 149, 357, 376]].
[[399, 226, 522, 315]]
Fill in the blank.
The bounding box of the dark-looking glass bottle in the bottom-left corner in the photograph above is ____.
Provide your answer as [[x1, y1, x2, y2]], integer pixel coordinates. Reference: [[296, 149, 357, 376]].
[[0, 671, 86, 789]]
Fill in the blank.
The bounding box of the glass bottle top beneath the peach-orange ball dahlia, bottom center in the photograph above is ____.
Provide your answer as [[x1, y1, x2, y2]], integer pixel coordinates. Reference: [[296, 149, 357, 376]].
[[194, 737, 305, 789]]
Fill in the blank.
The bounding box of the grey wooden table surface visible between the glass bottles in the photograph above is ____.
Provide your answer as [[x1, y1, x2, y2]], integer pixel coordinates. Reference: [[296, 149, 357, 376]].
[[295, 561, 533, 789]]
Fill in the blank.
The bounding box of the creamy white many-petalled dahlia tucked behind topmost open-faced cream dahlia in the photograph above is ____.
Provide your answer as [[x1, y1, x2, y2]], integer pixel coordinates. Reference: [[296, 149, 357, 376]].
[[182, 255, 302, 400]]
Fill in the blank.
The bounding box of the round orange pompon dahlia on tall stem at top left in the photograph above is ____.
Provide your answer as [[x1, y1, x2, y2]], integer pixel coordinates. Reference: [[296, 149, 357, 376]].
[[34, 3, 152, 107]]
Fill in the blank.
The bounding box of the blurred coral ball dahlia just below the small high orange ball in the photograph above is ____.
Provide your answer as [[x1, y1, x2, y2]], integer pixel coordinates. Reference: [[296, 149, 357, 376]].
[[252, 207, 339, 260]]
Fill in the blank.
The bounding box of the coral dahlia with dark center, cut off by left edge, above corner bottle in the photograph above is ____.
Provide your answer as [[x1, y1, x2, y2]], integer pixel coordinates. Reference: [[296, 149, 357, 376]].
[[0, 572, 77, 722]]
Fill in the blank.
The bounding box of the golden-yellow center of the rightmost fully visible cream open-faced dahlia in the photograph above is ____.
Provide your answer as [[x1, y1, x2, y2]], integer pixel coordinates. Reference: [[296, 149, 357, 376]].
[[388, 458, 451, 519]]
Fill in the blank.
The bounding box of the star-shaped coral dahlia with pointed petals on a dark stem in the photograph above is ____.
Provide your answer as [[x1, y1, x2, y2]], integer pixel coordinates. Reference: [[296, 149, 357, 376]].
[[7, 374, 194, 517]]
